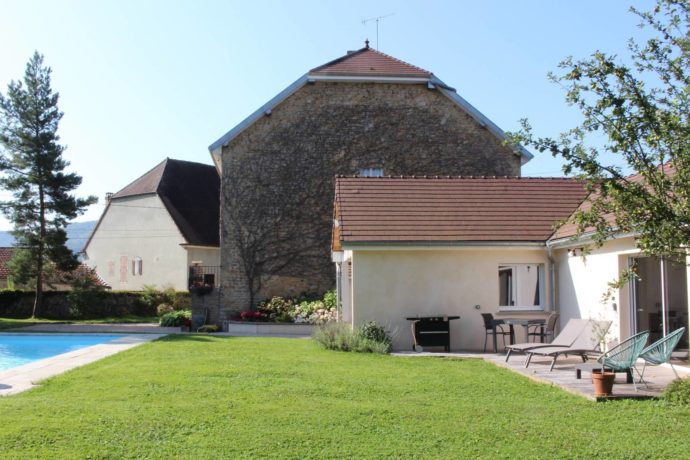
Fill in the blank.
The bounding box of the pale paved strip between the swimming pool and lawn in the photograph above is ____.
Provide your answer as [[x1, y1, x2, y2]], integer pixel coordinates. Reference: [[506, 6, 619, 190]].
[[0, 331, 166, 396]]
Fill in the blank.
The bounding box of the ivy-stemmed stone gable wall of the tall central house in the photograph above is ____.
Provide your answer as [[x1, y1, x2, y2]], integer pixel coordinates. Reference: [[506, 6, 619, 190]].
[[219, 82, 520, 319]]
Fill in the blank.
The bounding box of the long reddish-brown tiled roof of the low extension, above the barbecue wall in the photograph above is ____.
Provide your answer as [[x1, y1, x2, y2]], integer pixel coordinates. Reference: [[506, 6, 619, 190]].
[[333, 177, 586, 250]]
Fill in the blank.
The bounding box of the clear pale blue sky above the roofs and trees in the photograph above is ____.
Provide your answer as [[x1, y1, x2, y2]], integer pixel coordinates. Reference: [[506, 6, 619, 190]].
[[0, 0, 652, 229]]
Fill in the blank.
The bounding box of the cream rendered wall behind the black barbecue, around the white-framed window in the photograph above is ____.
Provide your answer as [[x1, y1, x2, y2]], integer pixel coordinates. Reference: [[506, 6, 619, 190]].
[[343, 248, 551, 350]]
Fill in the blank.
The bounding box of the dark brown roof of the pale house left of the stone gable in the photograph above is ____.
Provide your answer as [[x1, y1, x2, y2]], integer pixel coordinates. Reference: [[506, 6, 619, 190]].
[[107, 158, 220, 246]]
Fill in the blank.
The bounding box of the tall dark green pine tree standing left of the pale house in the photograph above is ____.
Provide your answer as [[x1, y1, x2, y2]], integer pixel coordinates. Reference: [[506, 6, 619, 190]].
[[0, 52, 96, 316]]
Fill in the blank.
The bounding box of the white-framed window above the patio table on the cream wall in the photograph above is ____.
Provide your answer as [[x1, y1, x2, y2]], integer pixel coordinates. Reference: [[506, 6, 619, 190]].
[[498, 264, 545, 310]]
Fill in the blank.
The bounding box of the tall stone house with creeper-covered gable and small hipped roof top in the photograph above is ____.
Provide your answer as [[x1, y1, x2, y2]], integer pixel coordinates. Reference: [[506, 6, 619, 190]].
[[209, 43, 532, 321]]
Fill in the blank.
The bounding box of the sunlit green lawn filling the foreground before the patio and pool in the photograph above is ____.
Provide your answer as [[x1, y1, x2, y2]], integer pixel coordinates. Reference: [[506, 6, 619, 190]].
[[0, 335, 690, 459]]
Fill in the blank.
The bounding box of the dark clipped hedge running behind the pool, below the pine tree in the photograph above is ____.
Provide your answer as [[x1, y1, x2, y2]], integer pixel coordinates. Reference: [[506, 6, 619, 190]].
[[0, 290, 189, 319]]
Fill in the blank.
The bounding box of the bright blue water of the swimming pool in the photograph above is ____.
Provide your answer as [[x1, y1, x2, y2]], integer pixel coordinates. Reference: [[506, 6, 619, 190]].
[[0, 333, 124, 371]]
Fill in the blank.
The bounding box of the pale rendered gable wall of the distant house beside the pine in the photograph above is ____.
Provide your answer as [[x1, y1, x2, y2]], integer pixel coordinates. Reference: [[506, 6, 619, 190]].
[[84, 194, 188, 290]]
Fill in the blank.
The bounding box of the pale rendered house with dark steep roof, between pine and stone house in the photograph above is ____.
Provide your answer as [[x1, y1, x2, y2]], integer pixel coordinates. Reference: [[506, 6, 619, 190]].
[[82, 158, 220, 290]]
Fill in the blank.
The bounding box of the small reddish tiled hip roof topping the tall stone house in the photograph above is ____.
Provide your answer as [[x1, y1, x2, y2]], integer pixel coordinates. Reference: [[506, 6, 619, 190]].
[[309, 45, 432, 78]]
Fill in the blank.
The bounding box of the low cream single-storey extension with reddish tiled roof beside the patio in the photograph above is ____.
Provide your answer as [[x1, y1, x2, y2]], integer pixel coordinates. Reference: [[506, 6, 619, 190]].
[[332, 177, 690, 353]]
